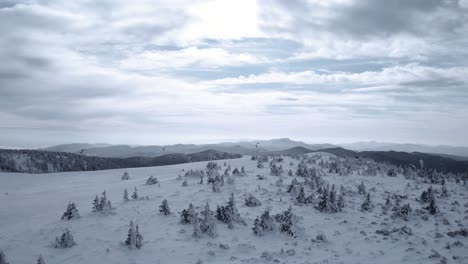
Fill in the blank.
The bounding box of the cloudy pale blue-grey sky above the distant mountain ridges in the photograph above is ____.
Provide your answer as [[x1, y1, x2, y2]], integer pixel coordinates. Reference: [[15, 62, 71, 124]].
[[0, 0, 468, 147]]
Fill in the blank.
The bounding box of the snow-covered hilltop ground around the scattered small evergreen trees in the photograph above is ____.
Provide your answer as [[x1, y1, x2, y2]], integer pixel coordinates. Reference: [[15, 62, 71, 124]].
[[0, 154, 468, 264]]
